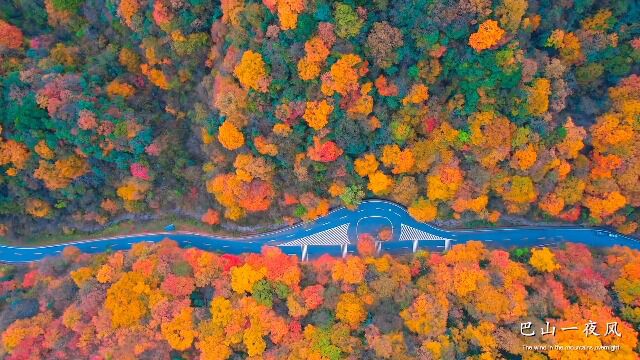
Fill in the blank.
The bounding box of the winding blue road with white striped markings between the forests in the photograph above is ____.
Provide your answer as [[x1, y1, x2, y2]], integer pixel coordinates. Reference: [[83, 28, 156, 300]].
[[0, 199, 640, 262]]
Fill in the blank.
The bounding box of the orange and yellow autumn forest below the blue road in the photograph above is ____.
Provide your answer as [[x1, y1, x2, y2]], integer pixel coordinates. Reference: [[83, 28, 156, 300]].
[[0, 236, 640, 360]]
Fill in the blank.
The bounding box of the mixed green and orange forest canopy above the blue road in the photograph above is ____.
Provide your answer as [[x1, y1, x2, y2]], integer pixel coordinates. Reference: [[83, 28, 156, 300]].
[[0, 0, 640, 238]]
